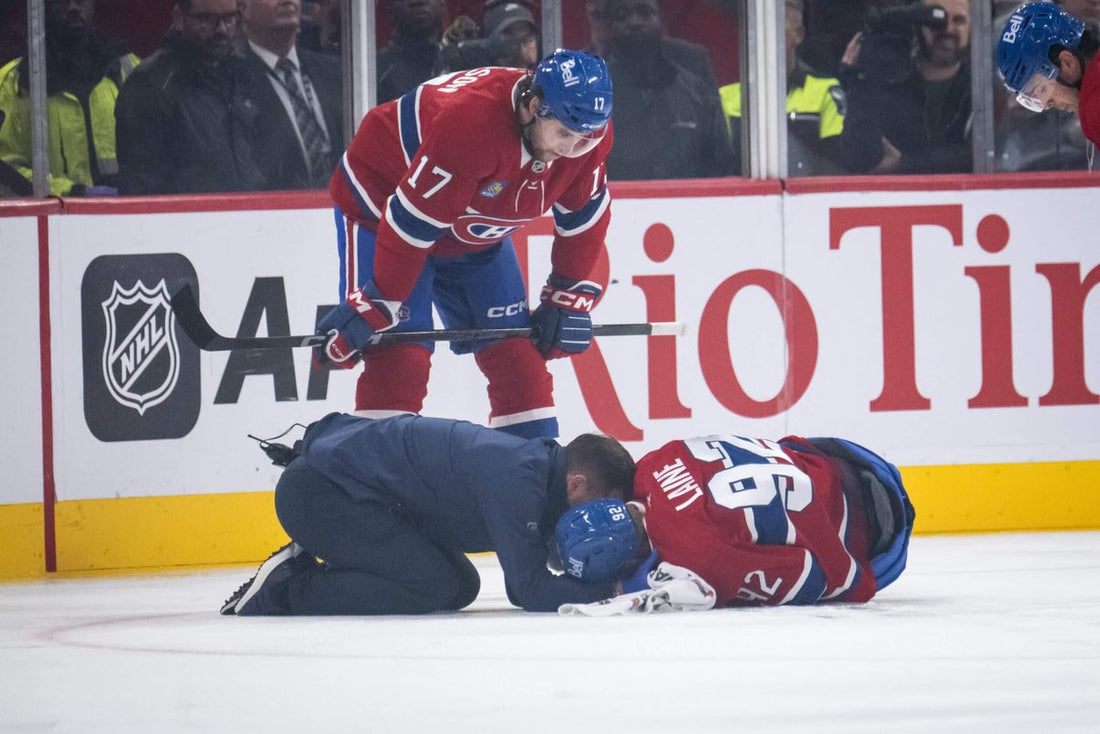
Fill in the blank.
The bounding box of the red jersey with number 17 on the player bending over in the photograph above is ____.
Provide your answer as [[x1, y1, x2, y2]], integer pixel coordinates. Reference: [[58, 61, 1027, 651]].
[[329, 68, 613, 300]]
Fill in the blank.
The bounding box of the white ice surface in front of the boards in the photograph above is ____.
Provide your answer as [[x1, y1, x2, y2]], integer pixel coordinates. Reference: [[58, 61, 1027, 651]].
[[0, 533, 1100, 734]]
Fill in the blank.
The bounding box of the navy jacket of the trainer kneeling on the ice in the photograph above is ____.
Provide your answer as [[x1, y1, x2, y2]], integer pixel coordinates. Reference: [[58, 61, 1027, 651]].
[[296, 414, 613, 612]]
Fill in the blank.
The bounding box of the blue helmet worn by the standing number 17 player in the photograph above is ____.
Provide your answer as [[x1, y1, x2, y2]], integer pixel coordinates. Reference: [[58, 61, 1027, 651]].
[[534, 48, 612, 134]]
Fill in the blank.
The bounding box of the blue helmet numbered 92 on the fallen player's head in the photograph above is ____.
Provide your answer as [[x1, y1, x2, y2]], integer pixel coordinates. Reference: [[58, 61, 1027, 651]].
[[554, 500, 642, 581]]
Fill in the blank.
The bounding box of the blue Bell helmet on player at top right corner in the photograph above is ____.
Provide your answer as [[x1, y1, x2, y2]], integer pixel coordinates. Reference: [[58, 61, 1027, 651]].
[[997, 2, 1085, 112]]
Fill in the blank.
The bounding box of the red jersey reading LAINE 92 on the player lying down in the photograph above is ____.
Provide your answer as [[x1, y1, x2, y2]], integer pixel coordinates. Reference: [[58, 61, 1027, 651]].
[[635, 436, 876, 606]]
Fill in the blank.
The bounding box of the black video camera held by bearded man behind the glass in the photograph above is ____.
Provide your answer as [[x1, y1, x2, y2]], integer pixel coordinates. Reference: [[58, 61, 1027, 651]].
[[856, 0, 947, 85]]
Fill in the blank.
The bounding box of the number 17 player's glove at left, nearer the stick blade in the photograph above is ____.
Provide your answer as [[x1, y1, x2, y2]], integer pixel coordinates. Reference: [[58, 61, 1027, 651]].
[[314, 288, 402, 369]]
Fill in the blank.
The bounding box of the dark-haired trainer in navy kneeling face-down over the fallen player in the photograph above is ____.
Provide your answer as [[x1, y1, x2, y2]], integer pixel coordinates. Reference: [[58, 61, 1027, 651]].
[[221, 413, 635, 615]]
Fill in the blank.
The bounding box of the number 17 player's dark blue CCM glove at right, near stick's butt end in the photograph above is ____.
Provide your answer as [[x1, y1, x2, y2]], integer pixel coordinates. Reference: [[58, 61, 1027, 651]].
[[530, 275, 603, 360]]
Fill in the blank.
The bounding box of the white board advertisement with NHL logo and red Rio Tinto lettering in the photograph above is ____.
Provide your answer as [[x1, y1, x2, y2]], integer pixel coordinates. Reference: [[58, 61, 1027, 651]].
[[32, 181, 1100, 500]]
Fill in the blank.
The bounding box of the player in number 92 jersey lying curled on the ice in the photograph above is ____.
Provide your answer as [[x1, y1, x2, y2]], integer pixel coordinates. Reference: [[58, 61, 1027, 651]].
[[554, 436, 914, 616]]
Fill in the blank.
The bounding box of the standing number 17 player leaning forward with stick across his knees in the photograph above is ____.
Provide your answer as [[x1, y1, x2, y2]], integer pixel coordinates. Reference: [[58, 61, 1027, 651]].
[[315, 51, 613, 438]]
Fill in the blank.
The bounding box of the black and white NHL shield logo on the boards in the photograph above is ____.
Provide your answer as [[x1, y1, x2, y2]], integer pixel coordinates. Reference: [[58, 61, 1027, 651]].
[[101, 278, 179, 415]]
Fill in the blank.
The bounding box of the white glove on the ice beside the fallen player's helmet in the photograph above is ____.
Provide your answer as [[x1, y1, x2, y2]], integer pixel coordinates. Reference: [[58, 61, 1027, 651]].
[[558, 561, 716, 616]]
